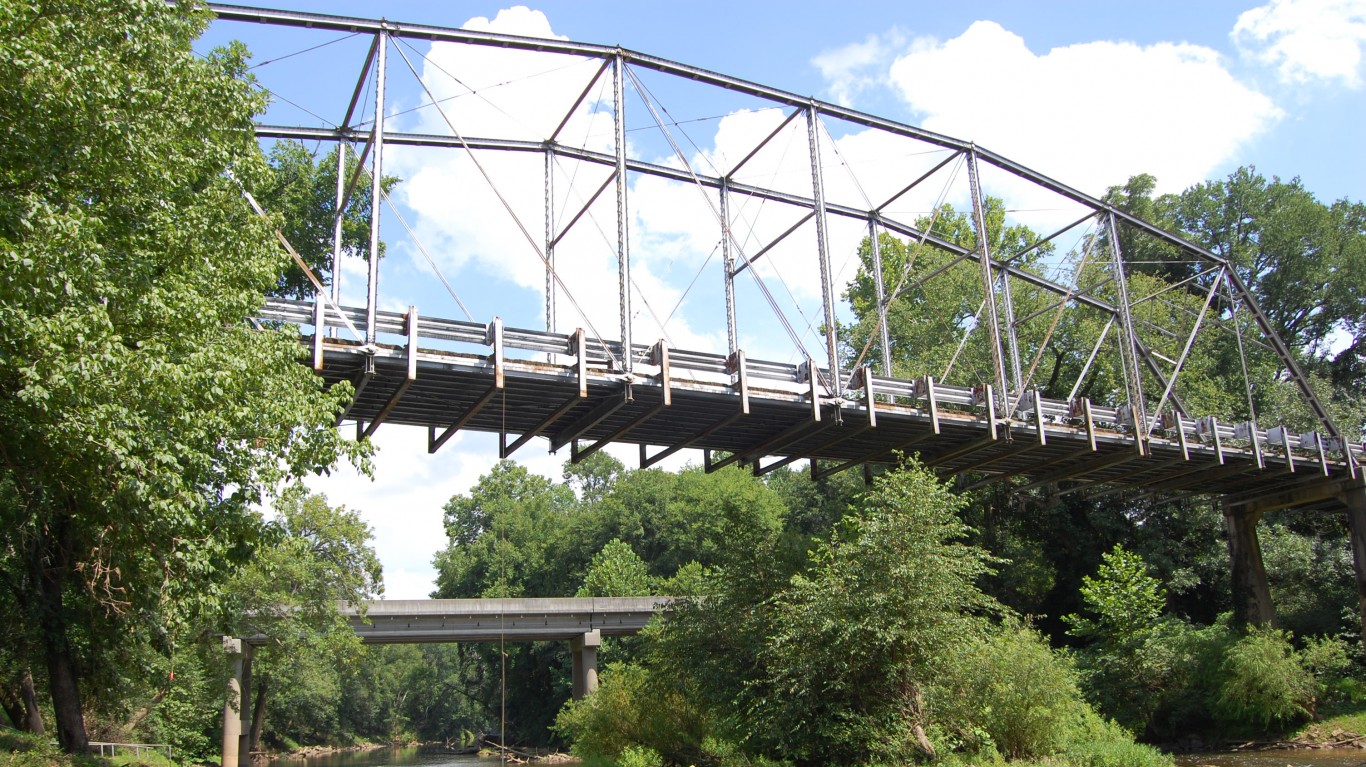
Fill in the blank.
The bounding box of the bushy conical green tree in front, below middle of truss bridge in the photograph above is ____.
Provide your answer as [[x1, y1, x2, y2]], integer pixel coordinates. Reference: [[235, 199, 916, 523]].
[[750, 463, 1000, 764]]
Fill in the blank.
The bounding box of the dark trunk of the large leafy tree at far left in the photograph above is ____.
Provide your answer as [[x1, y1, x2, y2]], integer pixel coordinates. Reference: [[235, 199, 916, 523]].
[[34, 518, 90, 753]]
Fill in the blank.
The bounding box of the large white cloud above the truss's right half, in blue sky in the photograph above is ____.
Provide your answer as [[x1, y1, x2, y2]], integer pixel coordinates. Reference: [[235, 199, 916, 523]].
[[889, 22, 1283, 194]]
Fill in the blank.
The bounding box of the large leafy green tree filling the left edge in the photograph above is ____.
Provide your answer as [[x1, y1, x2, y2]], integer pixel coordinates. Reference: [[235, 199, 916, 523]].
[[0, 0, 367, 751]]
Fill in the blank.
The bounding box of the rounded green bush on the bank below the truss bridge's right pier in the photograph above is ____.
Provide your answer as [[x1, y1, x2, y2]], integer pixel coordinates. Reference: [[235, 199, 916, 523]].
[[1210, 628, 1315, 729]]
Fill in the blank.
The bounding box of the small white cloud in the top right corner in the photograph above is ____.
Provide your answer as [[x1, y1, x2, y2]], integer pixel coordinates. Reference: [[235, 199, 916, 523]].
[[1232, 0, 1366, 89]]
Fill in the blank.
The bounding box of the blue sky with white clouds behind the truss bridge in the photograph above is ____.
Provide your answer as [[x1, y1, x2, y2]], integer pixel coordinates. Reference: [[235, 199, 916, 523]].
[[201, 0, 1366, 599]]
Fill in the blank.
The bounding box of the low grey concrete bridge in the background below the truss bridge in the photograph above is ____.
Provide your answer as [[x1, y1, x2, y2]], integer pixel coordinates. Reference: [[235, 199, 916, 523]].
[[223, 596, 672, 767]]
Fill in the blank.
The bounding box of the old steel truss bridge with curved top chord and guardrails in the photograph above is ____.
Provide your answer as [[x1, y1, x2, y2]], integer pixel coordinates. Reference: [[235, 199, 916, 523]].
[[212, 4, 1363, 507]]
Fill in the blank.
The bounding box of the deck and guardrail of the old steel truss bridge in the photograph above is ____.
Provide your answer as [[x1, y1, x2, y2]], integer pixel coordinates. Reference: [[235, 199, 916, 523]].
[[261, 301, 1362, 504]]
